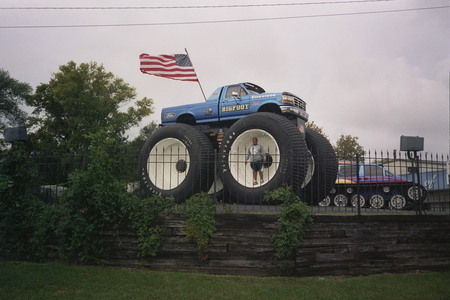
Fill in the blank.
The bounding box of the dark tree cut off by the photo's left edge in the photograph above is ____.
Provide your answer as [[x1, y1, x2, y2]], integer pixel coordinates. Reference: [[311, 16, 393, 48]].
[[0, 69, 32, 130]]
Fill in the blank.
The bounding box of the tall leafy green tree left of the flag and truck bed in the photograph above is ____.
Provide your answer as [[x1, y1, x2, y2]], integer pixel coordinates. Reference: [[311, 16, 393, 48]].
[[27, 61, 153, 152]]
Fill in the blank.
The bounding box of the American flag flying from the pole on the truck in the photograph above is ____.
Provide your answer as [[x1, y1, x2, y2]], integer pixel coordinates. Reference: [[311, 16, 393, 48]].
[[139, 53, 198, 81]]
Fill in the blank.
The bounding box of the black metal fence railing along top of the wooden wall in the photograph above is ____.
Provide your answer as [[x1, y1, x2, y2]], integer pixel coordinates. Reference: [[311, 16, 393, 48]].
[[17, 151, 450, 213]]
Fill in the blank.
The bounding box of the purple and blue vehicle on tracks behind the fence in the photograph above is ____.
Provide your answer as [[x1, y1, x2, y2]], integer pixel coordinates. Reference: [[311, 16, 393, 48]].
[[319, 161, 426, 209]]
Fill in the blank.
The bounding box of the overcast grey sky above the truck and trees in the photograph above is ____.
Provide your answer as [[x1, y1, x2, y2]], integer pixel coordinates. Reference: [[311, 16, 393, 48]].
[[0, 0, 450, 153]]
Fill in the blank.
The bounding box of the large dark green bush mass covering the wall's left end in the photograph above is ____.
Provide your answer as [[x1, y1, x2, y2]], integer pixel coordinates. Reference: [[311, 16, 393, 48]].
[[0, 134, 173, 263]]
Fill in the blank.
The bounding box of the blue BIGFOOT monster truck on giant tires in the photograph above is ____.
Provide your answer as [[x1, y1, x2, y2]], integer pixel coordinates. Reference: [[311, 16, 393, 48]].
[[140, 82, 337, 203]]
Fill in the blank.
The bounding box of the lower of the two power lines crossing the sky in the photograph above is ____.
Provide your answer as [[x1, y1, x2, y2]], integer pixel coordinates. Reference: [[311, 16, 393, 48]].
[[0, 5, 450, 29]]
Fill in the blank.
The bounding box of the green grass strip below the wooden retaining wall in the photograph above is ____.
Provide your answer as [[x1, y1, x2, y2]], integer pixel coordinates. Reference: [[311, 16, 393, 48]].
[[0, 262, 450, 300]]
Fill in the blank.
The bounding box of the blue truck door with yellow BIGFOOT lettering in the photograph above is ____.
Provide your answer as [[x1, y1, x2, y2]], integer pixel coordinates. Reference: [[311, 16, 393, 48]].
[[220, 84, 250, 120]]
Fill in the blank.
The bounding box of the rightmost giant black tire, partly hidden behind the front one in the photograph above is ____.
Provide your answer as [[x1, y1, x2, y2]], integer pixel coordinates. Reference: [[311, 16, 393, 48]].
[[303, 128, 338, 205]]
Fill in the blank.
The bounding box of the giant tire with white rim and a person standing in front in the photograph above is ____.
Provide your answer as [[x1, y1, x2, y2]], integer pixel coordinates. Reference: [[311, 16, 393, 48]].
[[219, 113, 307, 204]]
